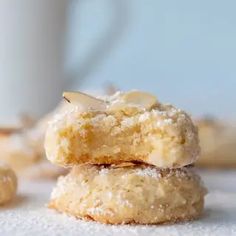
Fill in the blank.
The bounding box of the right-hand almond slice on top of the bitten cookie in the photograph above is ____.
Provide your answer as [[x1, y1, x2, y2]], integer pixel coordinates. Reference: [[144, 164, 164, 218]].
[[121, 91, 157, 109]]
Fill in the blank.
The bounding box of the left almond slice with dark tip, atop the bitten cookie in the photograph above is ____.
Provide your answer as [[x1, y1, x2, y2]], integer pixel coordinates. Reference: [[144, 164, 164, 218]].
[[63, 92, 106, 111]]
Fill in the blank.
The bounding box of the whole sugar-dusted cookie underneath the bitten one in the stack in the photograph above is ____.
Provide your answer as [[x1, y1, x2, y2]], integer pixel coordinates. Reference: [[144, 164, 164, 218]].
[[49, 165, 206, 224]]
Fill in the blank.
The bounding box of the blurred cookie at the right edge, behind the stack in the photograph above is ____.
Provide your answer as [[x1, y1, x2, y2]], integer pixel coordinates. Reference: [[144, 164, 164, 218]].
[[196, 119, 236, 168]]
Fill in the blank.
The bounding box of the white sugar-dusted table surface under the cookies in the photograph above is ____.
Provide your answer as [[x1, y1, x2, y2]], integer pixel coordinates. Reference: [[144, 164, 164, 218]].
[[0, 171, 236, 236]]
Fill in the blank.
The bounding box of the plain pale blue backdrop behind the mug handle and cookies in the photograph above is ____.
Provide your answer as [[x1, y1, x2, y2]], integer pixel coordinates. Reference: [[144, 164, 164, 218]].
[[67, 0, 236, 119]]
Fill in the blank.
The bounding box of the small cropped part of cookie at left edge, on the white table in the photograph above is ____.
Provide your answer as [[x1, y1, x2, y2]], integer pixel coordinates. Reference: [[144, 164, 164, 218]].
[[0, 164, 17, 204]]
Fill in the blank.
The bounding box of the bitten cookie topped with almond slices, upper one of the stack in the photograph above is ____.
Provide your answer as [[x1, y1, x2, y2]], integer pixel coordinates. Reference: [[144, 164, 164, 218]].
[[45, 91, 199, 168]]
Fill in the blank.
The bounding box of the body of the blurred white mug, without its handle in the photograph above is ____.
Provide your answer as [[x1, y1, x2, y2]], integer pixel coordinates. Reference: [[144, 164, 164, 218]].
[[0, 0, 127, 126]]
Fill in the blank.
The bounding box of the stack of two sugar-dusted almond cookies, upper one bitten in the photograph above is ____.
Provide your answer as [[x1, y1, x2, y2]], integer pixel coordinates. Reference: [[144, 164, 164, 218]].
[[45, 91, 205, 224]]
